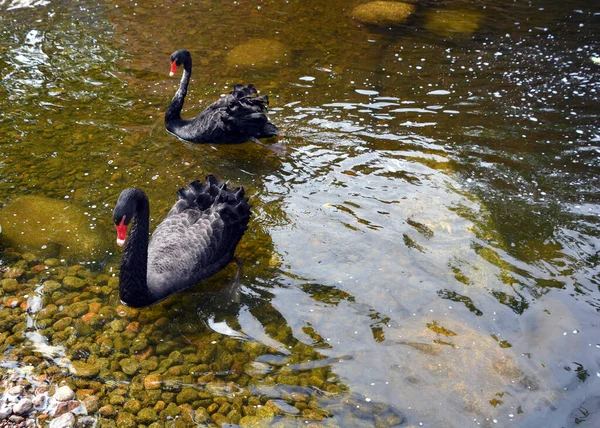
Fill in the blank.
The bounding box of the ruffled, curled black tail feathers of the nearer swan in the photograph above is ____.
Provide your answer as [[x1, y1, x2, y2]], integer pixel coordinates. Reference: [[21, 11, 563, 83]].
[[177, 174, 250, 232]]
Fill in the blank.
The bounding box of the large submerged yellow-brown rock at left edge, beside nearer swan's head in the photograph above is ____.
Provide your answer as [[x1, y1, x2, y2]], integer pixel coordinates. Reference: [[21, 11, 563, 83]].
[[0, 195, 109, 258]]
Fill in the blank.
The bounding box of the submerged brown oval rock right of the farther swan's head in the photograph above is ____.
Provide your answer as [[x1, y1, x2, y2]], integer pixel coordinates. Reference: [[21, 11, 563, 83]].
[[225, 39, 287, 67]]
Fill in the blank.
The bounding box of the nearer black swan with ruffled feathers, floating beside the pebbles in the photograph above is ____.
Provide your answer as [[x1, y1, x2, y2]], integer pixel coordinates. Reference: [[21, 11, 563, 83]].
[[113, 175, 250, 308]]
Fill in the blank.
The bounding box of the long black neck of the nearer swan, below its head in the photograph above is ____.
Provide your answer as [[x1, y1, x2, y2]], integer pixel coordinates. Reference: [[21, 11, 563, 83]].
[[119, 192, 155, 307]]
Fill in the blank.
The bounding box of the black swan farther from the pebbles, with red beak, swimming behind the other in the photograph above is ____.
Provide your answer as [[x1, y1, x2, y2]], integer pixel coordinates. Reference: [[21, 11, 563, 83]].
[[165, 49, 277, 144]]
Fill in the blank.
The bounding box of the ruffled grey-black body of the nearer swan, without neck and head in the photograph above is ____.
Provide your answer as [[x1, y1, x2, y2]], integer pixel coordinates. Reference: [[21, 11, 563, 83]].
[[147, 175, 250, 297]]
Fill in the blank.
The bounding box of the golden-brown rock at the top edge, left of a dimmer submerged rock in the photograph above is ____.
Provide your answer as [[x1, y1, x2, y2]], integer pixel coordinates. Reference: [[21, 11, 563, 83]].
[[352, 1, 415, 27]]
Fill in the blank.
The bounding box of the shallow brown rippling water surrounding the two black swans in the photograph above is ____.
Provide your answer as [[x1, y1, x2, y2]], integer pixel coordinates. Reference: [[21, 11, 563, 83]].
[[0, 0, 600, 427]]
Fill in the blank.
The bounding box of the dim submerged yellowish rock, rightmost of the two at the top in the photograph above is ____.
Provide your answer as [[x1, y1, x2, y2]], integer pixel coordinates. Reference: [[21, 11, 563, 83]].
[[425, 9, 481, 38]]
